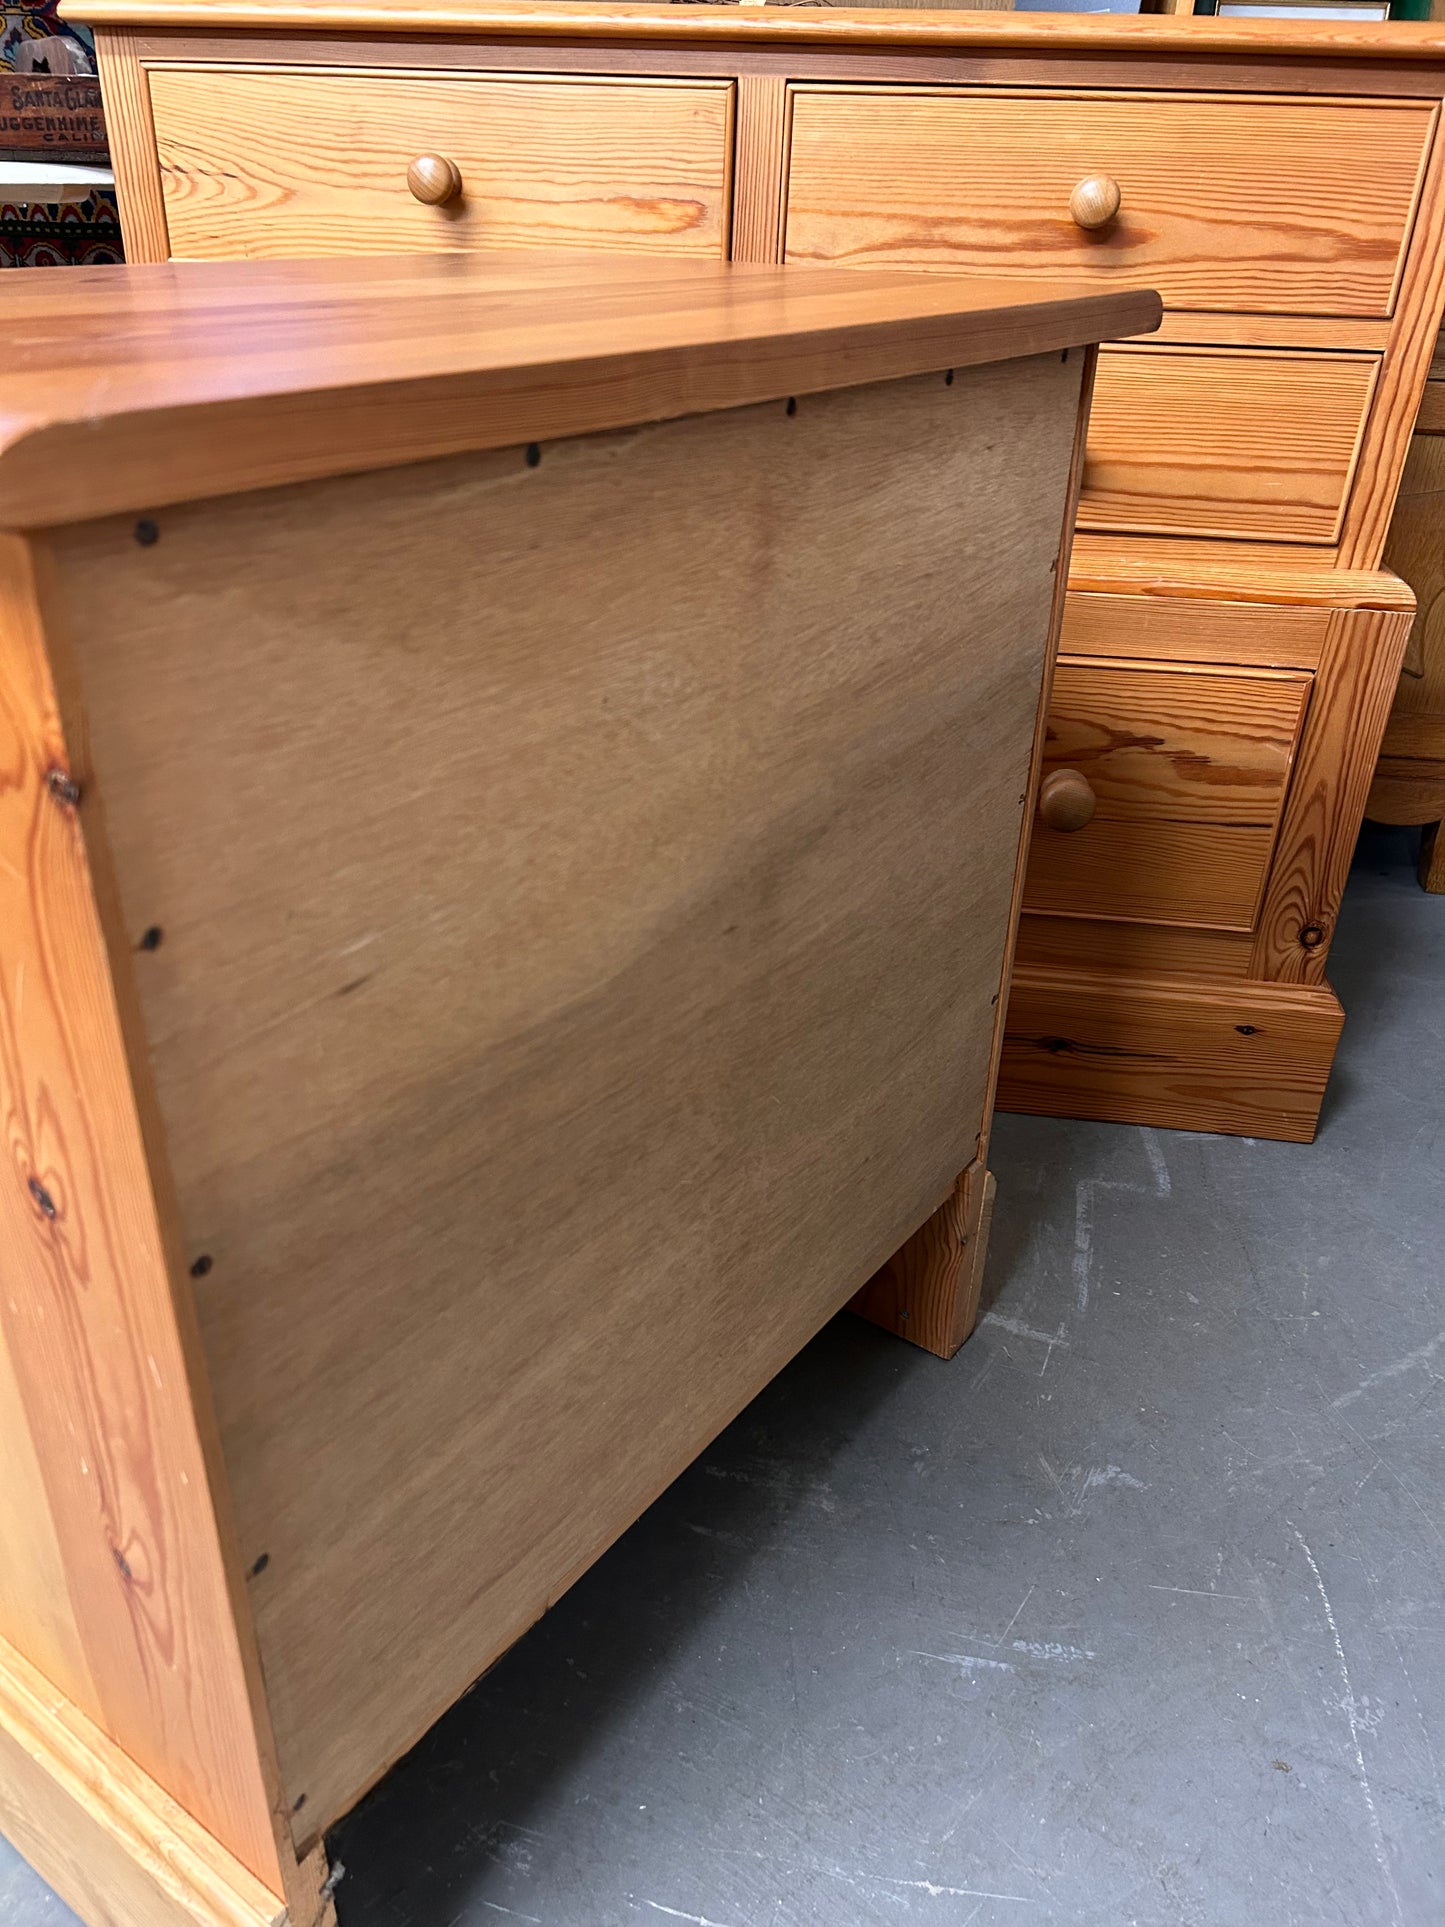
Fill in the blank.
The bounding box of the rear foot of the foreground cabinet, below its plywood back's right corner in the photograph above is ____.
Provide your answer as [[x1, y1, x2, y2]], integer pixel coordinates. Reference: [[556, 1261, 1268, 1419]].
[[852, 1164, 994, 1359]]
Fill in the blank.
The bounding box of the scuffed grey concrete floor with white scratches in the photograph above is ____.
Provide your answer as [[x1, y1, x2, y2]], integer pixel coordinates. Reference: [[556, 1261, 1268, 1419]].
[[0, 832, 1445, 1927]]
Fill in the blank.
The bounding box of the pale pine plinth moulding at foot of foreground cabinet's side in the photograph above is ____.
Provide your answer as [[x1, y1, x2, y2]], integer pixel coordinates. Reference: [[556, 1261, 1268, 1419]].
[[0, 1640, 285, 1927]]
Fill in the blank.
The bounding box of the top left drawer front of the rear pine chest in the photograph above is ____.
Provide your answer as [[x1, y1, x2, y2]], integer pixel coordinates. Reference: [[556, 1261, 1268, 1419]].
[[150, 67, 732, 260]]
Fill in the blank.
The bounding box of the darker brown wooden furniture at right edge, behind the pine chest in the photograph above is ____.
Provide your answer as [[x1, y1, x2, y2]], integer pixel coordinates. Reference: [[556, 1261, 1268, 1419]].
[[1366, 329, 1445, 892]]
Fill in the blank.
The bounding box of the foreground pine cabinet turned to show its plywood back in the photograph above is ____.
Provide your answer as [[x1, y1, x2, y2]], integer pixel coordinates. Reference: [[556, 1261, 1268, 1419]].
[[0, 254, 1160, 1927]]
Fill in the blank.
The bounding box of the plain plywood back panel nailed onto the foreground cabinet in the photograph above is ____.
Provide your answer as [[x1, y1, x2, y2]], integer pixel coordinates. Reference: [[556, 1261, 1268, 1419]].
[[56, 355, 1079, 1833]]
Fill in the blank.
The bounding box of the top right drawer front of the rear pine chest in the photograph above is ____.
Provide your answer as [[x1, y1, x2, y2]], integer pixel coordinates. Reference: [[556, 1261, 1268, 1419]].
[[786, 87, 1435, 316]]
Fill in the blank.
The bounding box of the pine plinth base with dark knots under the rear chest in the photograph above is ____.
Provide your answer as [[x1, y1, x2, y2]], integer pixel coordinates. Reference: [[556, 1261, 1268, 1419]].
[[998, 969, 1345, 1143]]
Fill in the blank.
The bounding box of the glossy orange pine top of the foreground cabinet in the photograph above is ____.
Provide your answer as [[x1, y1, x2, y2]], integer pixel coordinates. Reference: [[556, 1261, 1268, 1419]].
[[0, 254, 1160, 528]]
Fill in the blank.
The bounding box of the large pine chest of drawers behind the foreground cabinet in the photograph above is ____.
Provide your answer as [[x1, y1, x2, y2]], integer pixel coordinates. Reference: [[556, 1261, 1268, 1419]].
[[71, 0, 1445, 1139]]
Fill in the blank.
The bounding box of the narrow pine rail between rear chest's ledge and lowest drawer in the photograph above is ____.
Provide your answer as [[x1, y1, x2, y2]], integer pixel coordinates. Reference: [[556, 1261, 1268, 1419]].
[[1060, 592, 1329, 669]]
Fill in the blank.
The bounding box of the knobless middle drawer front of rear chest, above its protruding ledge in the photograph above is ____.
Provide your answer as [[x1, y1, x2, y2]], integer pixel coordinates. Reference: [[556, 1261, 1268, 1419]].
[[1079, 347, 1379, 543]]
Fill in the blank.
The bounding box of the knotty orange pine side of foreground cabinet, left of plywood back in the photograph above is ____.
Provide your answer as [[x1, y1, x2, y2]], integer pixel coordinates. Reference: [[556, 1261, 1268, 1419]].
[[0, 538, 279, 1890]]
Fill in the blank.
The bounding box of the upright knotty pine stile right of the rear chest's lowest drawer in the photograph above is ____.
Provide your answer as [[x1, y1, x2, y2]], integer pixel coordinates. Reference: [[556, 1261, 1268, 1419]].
[[1250, 609, 1410, 983]]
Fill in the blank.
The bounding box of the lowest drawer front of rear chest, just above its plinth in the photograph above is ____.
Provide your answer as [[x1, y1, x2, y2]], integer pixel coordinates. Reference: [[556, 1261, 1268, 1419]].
[[1023, 661, 1312, 931]]
